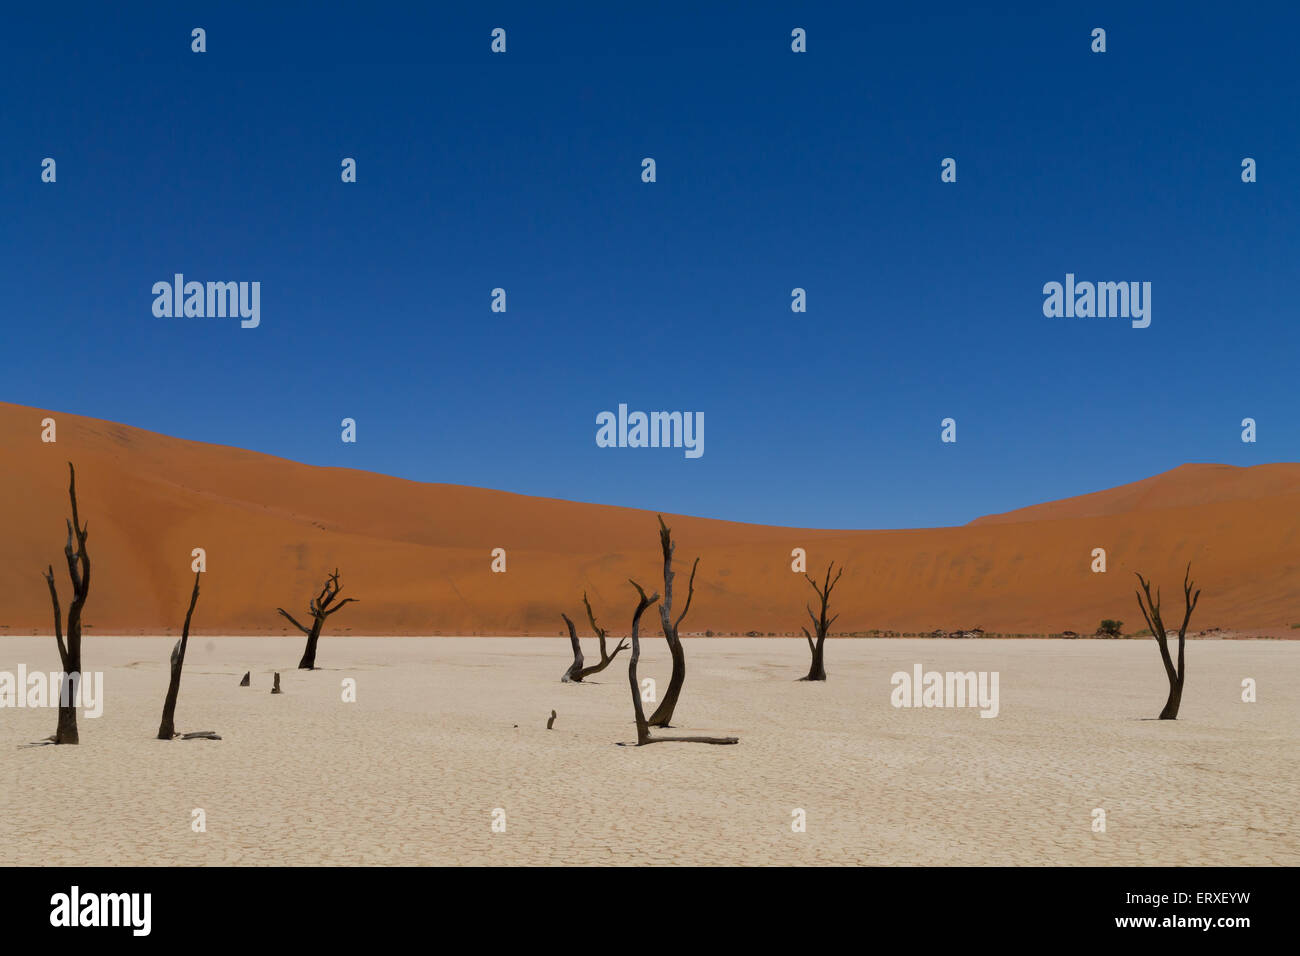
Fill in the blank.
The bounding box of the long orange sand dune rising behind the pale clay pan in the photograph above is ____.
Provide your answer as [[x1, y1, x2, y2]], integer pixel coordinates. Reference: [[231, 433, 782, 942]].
[[0, 403, 1300, 635]]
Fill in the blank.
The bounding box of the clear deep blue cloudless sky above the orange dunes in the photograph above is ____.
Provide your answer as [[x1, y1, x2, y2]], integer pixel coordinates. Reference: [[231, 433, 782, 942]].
[[0, 3, 1300, 528]]
